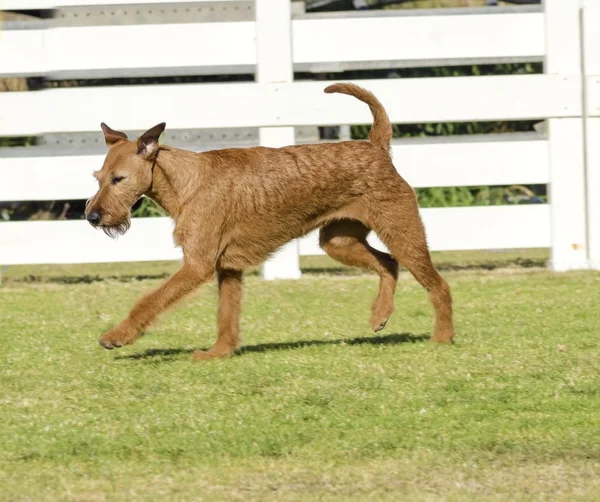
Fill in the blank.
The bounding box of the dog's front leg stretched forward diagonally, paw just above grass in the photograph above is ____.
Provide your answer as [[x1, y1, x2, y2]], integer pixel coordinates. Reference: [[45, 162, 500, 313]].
[[99, 263, 214, 349]]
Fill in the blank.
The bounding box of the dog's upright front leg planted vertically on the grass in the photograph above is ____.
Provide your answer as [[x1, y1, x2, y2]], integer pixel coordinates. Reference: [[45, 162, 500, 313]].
[[193, 269, 242, 360]]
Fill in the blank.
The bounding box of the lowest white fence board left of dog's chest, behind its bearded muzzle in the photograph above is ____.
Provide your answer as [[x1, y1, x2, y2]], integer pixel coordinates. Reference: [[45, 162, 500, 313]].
[[0, 218, 182, 265]]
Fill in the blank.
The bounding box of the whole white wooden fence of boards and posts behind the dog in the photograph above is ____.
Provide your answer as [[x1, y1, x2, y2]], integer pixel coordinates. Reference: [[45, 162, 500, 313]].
[[0, 0, 600, 278]]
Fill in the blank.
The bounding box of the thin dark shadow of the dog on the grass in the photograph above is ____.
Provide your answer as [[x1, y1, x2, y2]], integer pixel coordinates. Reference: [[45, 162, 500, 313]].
[[115, 333, 430, 361]]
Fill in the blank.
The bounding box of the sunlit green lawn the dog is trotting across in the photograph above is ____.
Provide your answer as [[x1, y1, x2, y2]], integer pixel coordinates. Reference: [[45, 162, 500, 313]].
[[0, 255, 600, 501]]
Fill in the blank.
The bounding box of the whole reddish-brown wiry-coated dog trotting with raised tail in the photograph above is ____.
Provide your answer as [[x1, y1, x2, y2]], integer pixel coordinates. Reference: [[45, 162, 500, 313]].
[[86, 84, 454, 359]]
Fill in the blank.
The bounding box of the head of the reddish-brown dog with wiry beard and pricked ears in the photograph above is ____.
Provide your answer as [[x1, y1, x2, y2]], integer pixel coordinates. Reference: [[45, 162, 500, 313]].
[[85, 123, 166, 237]]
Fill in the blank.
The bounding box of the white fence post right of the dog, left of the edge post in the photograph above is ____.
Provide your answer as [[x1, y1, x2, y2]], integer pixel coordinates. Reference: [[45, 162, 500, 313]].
[[543, 0, 588, 271]]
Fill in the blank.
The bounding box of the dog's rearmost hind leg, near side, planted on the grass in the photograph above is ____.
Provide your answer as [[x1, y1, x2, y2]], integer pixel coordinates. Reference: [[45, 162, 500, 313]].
[[369, 198, 455, 342]]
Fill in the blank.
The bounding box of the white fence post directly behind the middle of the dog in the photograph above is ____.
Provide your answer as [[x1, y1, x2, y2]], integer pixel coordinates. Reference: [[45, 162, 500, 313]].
[[255, 0, 301, 280]]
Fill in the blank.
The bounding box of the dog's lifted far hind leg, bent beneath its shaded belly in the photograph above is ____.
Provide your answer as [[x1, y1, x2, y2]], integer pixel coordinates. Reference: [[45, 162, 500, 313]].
[[319, 220, 398, 331]]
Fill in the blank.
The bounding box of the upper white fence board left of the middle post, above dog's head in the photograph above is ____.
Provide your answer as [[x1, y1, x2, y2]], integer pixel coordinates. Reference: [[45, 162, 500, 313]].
[[0, 22, 256, 76]]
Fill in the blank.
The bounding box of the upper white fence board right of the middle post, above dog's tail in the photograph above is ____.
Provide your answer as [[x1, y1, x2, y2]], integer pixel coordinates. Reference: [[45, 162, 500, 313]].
[[293, 12, 545, 63]]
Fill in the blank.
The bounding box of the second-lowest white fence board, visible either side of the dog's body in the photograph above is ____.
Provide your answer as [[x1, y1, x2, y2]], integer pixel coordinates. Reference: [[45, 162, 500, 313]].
[[0, 134, 549, 201]]
